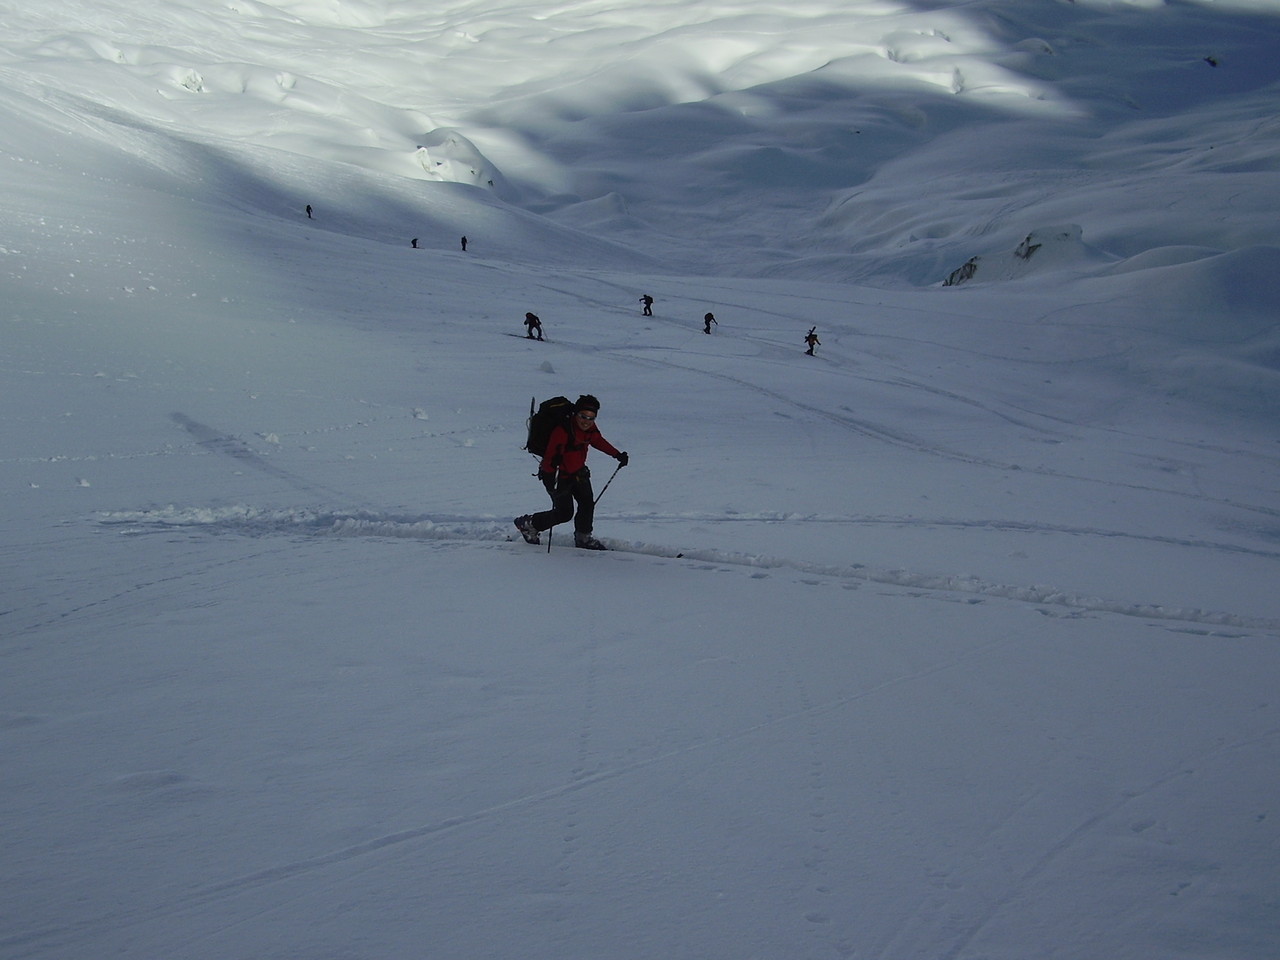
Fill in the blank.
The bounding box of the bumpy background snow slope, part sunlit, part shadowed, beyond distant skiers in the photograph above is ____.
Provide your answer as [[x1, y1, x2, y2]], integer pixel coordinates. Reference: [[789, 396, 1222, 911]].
[[0, 0, 1280, 284]]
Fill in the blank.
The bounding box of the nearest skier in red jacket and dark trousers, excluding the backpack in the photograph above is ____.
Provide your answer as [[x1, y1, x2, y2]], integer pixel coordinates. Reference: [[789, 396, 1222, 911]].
[[515, 394, 627, 550]]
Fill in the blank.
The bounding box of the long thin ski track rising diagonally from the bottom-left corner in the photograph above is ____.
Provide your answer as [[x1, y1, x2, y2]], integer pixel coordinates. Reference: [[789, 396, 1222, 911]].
[[0, 639, 1014, 947]]
